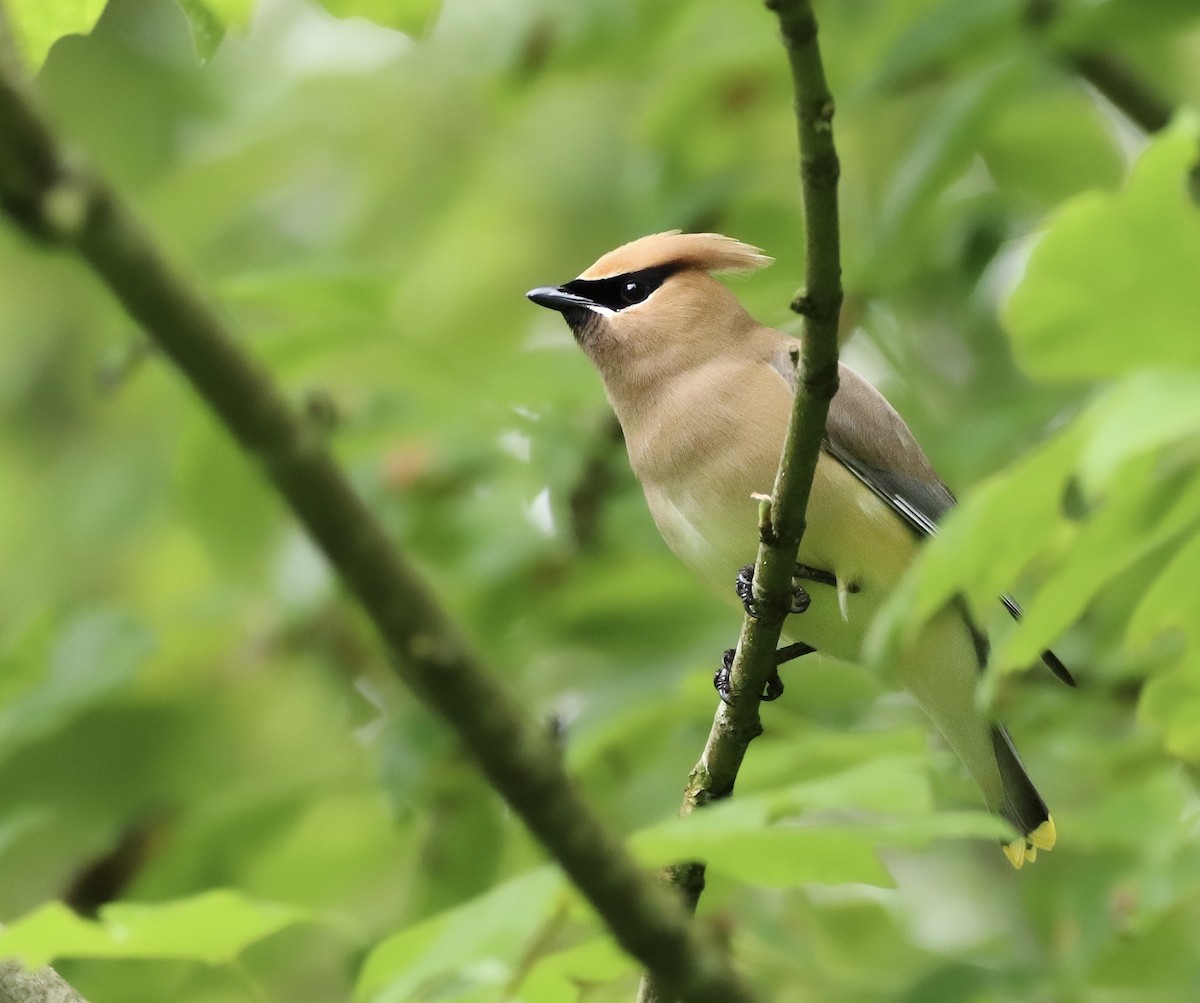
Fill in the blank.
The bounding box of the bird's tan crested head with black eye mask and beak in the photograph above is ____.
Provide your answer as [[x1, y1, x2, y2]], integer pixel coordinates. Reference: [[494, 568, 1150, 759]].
[[527, 230, 772, 386]]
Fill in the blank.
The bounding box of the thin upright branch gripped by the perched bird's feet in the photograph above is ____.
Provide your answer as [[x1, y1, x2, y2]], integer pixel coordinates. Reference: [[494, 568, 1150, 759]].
[[638, 0, 842, 1003]]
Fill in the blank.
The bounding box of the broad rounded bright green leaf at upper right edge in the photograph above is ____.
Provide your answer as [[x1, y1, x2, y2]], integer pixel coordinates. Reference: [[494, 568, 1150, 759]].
[[1004, 115, 1200, 379]]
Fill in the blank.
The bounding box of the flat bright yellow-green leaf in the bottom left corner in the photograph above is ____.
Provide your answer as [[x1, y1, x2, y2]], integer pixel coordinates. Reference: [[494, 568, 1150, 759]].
[[0, 890, 313, 968]]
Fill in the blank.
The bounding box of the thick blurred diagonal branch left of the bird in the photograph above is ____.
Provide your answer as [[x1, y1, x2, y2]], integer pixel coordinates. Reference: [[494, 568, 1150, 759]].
[[0, 7, 754, 1003]]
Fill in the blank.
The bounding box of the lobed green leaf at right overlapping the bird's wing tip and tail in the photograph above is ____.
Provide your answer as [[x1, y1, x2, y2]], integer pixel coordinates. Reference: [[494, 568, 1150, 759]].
[[866, 372, 1200, 668]]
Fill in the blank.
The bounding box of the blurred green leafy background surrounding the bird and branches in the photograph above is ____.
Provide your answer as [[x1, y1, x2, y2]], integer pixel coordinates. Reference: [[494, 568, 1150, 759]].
[[0, 0, 1200, 1003]]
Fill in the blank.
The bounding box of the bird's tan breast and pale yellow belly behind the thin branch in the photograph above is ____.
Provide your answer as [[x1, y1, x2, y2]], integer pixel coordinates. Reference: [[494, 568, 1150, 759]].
[[610, 358, 917, 660]]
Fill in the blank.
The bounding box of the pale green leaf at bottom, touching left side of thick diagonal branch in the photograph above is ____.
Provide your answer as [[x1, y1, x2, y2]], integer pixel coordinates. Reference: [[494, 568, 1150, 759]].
[[355, 867, 563, 1003]]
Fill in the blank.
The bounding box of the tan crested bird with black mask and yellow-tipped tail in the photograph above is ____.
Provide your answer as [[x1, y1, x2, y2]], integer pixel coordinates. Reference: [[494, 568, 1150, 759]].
[[527, 230, 1074, 867]]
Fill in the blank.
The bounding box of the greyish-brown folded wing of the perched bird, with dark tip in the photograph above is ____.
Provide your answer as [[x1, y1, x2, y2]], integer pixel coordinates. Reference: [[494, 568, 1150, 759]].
[[769, 344, 1075, 686]]
